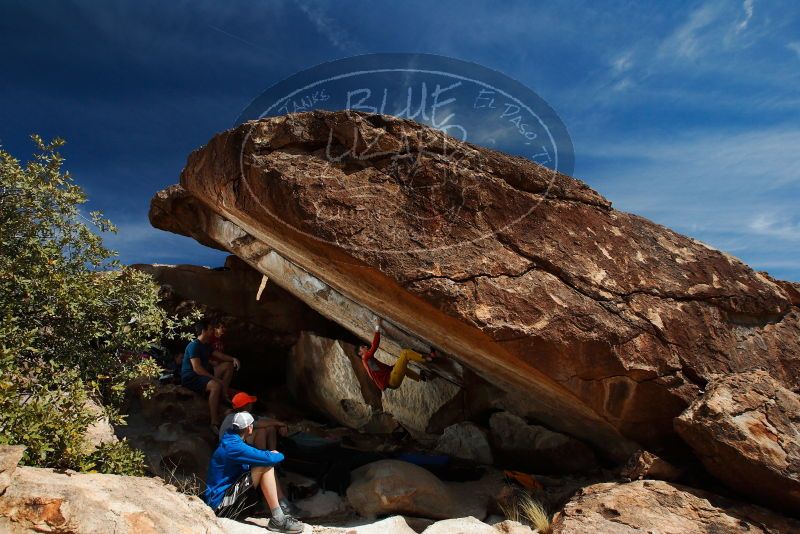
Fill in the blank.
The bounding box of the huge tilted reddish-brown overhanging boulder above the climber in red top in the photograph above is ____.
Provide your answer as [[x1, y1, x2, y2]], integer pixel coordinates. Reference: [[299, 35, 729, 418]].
[[150, 112, 800, 458]]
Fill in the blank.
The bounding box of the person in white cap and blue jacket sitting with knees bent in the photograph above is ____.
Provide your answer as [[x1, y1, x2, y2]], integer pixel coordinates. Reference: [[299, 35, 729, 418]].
[[203, 412, 305, 533]]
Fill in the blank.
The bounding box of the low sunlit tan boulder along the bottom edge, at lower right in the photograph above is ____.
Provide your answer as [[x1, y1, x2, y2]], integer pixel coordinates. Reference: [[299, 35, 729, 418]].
[[553, 480, 800, 534]]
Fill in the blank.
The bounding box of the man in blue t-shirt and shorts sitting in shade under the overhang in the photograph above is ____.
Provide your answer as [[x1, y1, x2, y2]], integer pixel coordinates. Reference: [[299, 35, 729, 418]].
[[181, 319, 240, 434]]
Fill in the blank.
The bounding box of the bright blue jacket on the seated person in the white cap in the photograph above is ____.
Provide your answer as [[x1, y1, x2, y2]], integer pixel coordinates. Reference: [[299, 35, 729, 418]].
[[203, 430, 283, 509]]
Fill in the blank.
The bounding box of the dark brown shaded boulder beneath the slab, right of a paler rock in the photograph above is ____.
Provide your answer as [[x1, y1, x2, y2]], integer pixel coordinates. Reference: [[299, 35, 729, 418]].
[[489, 412, 597, 473]]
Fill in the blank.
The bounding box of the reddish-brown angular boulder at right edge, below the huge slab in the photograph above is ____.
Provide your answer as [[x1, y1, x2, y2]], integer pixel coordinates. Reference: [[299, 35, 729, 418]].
[[675, 371, 800, 513]]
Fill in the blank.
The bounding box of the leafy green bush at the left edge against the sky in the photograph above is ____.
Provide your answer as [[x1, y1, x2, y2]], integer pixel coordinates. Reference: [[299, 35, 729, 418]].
[[0, 136, 183, 473]]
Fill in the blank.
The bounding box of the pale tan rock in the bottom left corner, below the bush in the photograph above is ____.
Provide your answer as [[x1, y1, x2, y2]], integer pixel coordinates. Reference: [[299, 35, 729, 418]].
[[0, 450, 224, 534]]
